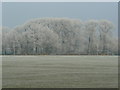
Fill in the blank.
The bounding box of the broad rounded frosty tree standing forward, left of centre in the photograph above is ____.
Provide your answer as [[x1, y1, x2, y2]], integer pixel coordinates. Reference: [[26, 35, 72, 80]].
[[12, 21, 59, 54]]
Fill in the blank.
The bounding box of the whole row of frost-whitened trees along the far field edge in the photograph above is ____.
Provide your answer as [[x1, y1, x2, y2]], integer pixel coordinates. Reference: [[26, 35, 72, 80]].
[[2, 18, 118, 55]]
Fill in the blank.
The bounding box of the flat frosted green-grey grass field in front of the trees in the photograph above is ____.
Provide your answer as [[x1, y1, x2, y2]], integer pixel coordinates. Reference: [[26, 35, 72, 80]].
[[2, 56, 118, 88]]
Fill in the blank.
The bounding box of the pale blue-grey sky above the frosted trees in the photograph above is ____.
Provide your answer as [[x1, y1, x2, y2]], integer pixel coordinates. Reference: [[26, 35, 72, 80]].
[[0, 2, 118, 35]]
